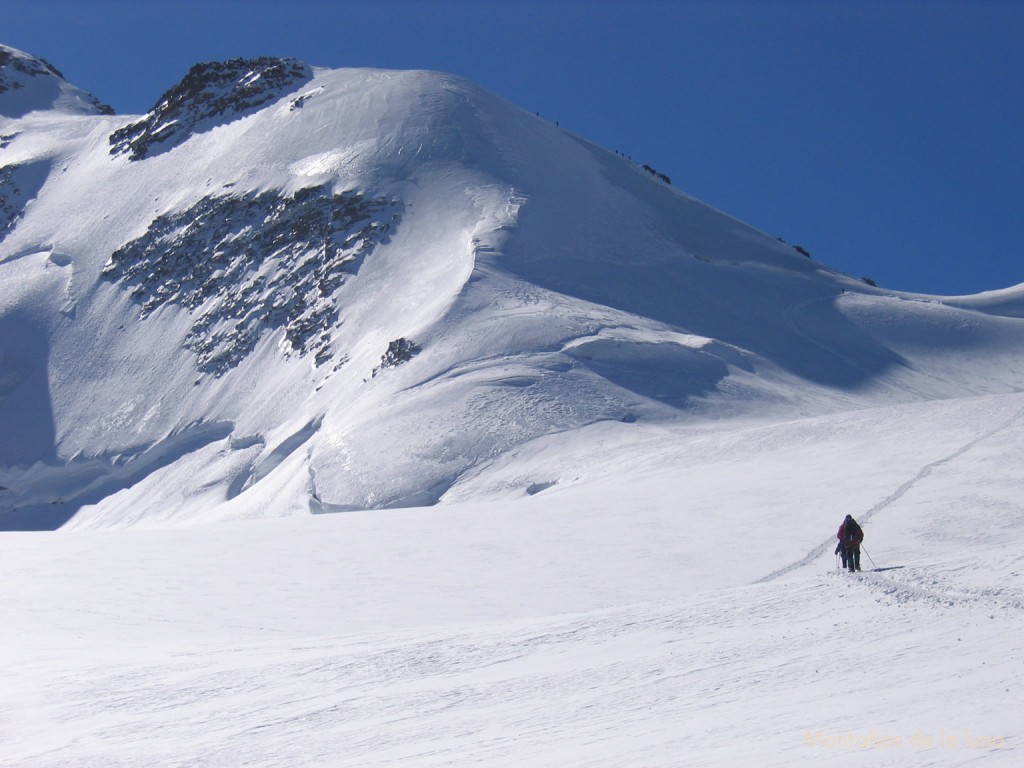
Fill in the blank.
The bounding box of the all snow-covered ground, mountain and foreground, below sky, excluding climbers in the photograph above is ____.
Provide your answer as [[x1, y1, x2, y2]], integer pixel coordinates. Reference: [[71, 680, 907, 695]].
[[0, 47, 1024, 768]]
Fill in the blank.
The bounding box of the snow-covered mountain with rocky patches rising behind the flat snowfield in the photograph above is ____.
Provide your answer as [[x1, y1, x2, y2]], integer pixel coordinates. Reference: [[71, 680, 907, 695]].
[[0, 48, 1024, 527]]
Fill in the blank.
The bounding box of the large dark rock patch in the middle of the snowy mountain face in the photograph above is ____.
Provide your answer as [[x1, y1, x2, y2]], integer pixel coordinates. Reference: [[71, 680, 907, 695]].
[[103, 184, 401, 375]]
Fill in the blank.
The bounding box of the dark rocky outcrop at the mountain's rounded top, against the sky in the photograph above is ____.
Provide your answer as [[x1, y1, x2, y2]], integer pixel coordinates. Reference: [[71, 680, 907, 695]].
[[111, 56, 312, 160]]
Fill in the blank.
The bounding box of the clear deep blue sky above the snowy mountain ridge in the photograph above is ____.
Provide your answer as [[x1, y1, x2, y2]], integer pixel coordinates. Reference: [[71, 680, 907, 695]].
[[0, 0, 1024, 294]]
